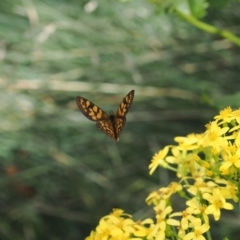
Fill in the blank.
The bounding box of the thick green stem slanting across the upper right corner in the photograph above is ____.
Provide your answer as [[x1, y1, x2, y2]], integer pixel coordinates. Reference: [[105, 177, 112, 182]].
[[175, 10, 240, 46]]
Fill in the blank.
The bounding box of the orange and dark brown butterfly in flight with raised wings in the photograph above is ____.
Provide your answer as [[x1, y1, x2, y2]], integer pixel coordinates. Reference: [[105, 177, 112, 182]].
[[76, 90, 134, 141]]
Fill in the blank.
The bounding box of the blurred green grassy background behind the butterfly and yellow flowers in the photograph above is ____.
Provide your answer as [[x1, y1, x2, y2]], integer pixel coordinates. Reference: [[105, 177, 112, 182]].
[[0, 0, 240, 240]]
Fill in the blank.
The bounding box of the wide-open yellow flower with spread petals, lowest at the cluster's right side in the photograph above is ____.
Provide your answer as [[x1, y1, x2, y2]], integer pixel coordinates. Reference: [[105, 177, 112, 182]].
[[203, 188, 233, 221]]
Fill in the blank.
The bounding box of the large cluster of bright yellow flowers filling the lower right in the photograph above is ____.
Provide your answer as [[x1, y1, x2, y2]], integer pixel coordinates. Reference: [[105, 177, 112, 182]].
[[86, 107, 240, 240]]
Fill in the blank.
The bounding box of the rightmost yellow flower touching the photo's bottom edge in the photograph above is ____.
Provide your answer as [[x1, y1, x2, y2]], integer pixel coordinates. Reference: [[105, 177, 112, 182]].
[[183, 218, 210, 240]]
